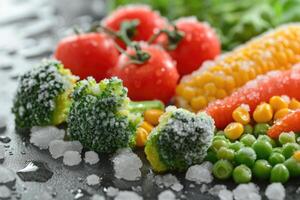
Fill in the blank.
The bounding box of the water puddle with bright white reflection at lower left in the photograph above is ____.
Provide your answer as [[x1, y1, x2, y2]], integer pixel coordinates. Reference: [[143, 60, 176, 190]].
[[17, 161, 53, 182]]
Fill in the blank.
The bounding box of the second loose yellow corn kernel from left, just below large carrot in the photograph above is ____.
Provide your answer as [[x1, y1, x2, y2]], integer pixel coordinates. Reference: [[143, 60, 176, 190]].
[[253, 103, 273, 123]]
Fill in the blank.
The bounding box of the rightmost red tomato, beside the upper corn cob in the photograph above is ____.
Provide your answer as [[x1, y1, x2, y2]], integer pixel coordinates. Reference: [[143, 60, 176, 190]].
[[156, 18, 221, 76]]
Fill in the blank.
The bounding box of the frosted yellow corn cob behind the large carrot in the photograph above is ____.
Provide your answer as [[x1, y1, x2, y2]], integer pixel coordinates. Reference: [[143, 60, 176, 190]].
[[175, 23, 300, 112]]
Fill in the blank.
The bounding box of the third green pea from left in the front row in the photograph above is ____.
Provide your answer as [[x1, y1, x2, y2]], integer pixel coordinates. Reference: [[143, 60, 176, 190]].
[[252, 160, 272, 180]]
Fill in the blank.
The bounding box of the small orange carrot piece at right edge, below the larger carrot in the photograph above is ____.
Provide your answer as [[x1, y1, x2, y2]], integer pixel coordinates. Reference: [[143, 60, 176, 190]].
[[268, 109, 300, 138]]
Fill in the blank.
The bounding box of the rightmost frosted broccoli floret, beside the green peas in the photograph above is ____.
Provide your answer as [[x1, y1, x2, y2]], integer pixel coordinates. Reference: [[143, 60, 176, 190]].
[[145, 106, 215, 172]]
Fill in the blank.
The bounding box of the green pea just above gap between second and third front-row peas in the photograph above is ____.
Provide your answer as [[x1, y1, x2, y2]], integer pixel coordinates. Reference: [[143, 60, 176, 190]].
[[235, 147, 256, 167]]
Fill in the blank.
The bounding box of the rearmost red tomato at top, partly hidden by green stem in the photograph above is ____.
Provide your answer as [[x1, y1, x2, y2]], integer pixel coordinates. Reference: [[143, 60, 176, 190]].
[[102, 5, 166, 47]]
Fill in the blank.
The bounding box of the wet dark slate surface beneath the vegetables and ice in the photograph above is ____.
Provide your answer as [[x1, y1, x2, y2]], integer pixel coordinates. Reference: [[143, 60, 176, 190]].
[[0, 0, 300, 200]]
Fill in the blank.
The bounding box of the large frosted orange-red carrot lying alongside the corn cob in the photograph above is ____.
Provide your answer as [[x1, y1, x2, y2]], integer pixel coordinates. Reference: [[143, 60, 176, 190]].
[[204, 67, 300, 128]]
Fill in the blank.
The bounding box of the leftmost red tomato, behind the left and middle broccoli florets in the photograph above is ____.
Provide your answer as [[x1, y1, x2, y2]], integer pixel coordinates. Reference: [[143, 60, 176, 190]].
[[55, 33, 119, 81]]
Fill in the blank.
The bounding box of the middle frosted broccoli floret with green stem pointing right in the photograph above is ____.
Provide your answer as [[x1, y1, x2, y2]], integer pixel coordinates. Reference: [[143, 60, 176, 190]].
[[67, 78, 164, 153]]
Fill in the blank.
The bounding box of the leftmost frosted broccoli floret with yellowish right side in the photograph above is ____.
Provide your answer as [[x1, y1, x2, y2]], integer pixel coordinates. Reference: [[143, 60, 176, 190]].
[[12, 60, 76, 129]]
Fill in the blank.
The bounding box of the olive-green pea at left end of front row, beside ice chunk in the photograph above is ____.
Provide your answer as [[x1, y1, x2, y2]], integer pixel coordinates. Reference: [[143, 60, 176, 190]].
[[212, 160, 233, 180]]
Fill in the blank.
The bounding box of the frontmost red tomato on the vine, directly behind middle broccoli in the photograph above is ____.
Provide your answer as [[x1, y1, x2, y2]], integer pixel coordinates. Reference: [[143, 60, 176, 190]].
[[111, 43, 179, 103]]
